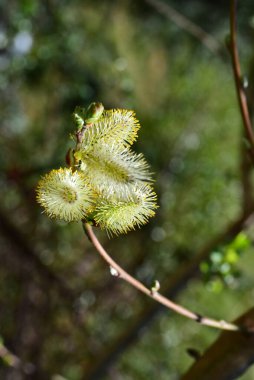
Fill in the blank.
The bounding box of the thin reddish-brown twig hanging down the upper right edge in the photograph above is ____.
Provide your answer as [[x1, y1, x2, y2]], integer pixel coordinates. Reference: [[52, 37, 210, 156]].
[[230, 0, 254, 163]]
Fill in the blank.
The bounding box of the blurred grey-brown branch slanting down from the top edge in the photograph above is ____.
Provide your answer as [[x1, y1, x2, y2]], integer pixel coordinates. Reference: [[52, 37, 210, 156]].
[[145, 0, 223, 55]]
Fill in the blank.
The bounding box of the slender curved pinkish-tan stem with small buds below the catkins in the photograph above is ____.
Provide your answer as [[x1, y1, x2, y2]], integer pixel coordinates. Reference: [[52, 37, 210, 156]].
[[83, 223, 245, 331]]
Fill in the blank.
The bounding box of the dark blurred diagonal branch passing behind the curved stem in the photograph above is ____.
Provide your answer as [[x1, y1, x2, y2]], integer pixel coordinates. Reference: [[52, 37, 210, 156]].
[[85, 209, 254, 380]]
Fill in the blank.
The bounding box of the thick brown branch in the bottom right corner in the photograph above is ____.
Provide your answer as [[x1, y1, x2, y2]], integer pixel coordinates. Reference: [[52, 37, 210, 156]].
[[181, 308, 254, 380]]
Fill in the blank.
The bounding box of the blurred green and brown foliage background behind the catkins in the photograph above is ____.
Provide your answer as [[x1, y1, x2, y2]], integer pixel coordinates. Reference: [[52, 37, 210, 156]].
[[0, 0, 254, 380]]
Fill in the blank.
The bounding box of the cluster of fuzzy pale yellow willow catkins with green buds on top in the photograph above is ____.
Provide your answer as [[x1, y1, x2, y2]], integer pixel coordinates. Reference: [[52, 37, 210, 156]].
[[37, 103, 157, 235]]
